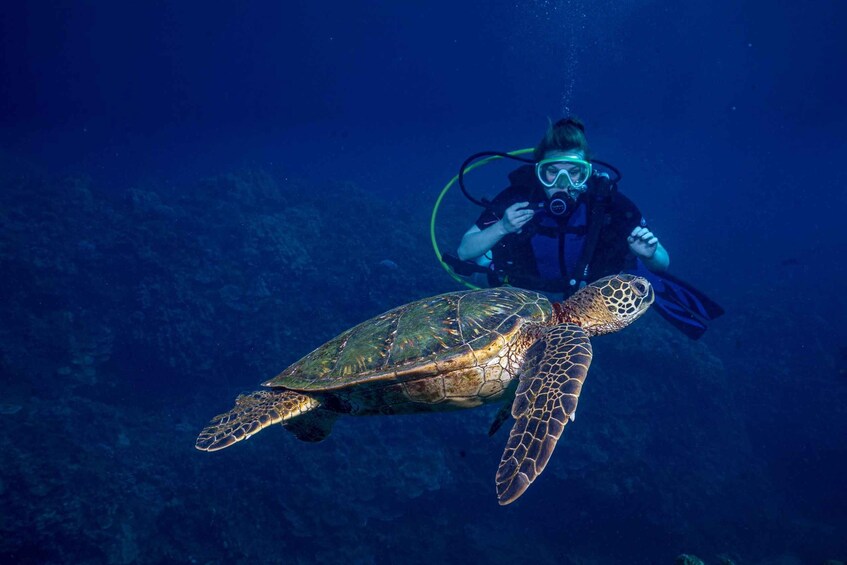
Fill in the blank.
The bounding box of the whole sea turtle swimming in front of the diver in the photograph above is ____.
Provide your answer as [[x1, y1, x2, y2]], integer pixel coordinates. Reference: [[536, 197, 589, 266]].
[[196, 275, 653, 505]]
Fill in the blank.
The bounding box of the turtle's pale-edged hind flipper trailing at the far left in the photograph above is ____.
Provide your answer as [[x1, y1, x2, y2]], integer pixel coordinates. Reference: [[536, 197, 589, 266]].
[[194, 390, 320, 451]]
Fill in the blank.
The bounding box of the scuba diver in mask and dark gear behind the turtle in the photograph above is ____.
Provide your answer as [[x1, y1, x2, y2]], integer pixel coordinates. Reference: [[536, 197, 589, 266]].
[[443, 117, 723, 339]]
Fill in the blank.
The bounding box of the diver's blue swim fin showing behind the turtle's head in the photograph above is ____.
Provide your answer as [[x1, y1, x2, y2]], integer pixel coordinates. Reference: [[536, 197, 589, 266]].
[[635, 260, 724, 339]]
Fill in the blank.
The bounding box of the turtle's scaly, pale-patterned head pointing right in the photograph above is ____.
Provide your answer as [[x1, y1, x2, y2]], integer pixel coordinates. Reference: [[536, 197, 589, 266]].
[[557, 274, 655, 335]]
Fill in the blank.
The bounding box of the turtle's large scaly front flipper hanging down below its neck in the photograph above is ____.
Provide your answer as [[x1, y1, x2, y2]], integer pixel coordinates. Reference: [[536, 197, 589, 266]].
[[496, 324, 591, 505]]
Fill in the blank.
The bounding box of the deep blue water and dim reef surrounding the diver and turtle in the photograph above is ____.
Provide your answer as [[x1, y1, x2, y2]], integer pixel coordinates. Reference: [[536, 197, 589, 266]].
[[0, 0, 847, 565]]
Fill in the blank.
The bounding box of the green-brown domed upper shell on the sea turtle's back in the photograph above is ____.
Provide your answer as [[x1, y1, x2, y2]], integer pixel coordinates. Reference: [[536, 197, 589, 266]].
[[264, 287, 552, 391]]
